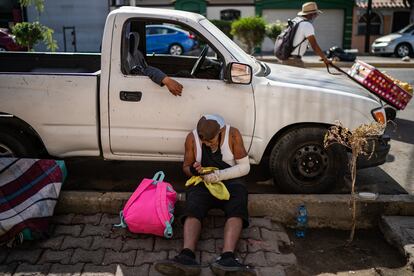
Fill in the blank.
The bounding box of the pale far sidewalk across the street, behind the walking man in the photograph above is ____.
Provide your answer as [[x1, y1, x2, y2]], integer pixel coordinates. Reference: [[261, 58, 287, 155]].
[[255, 54, 414, 68]]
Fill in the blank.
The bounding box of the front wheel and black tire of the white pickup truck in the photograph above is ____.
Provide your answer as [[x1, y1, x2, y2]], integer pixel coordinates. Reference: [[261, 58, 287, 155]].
[[269, 126, 348, 194]]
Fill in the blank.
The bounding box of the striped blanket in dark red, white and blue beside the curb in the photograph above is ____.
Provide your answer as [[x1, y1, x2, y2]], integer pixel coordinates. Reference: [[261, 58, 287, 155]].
[[0, 158, 66, 244]]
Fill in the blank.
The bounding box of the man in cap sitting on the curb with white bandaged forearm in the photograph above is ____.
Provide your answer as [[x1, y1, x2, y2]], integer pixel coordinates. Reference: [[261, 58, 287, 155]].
[[155, 115, 256, 276]]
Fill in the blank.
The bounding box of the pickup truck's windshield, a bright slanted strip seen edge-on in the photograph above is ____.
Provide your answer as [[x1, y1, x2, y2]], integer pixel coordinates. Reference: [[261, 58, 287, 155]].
[[200, 19, 260, 72]]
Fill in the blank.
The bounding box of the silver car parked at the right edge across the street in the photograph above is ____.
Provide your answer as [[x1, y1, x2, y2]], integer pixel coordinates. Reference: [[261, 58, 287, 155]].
[[371, 24, 414, 57]]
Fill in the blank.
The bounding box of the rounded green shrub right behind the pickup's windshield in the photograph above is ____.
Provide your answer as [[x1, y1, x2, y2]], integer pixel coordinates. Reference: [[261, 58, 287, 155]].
[[231, 16, 266, 54]]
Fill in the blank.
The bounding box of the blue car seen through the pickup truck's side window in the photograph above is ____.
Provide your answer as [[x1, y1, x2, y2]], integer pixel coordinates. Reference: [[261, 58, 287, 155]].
[[146, 25, 196, 56]]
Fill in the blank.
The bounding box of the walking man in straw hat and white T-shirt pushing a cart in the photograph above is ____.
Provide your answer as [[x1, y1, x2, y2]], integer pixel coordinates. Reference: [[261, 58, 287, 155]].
[[281, 2, 330, 67]]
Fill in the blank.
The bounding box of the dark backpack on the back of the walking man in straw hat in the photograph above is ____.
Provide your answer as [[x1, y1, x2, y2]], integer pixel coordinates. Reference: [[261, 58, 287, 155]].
[[273, 17, 306, 60]]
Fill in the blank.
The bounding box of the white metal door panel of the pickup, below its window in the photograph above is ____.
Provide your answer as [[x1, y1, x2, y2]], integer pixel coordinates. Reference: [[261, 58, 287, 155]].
[[109, 72, 254, 160]]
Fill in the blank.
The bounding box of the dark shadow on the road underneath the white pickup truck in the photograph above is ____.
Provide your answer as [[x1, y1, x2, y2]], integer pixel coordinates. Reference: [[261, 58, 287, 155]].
[[63, 158, 406, 194]]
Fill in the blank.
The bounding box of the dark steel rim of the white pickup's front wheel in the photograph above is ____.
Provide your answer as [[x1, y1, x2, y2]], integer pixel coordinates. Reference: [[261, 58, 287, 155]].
[[289, 144, 328, 181]]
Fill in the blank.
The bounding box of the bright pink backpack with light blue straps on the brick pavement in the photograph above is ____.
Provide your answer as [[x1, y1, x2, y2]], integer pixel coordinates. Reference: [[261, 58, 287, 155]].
[[115, 171, 177, 238]]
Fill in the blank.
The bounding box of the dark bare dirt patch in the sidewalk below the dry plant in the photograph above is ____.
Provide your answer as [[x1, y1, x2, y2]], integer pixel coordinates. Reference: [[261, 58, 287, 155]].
[[287, 229, 406, 276]]
